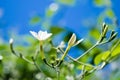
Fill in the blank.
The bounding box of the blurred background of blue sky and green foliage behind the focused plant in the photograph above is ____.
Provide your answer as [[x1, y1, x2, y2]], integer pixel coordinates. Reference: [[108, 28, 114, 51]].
[[0, 0, 120, 80]]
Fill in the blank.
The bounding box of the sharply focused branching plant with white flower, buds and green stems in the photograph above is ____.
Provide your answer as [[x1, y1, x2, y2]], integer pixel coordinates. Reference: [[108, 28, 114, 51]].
[[9, 23, 120, 80]]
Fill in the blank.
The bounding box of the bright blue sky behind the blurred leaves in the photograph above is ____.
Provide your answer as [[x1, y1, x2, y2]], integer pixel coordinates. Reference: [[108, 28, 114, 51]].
[[0, 0, 120, 38]]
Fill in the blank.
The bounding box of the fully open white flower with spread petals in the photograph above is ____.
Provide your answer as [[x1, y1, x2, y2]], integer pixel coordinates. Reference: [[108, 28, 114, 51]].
[[30, 30, 52, 41]]
